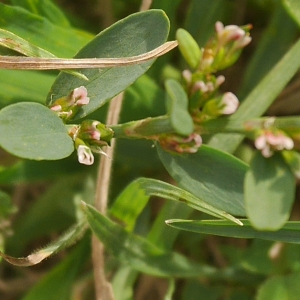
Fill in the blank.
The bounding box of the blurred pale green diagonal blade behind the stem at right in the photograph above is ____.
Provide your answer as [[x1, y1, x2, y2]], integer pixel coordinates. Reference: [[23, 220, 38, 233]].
[[209, 40, 300, 152]]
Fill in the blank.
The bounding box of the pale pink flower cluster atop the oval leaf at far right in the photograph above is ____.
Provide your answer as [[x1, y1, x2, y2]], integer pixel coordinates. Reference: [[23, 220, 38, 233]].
[[254, 129, 294, 158]]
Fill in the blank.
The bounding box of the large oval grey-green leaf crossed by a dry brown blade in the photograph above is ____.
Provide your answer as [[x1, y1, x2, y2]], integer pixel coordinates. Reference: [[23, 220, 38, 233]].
[[47, 10, 169, 119]]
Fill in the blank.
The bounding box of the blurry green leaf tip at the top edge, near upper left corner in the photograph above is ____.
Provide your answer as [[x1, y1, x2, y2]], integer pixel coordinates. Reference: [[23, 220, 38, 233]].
[[11, 0, 70, 27]]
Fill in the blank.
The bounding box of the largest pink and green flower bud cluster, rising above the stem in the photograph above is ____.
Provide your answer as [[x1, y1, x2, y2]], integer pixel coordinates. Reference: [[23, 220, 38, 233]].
[[178, 22, 251, 123]]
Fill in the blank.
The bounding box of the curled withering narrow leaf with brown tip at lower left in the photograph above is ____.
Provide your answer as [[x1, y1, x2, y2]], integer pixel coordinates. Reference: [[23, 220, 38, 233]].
[[0, 223, 86, 267]]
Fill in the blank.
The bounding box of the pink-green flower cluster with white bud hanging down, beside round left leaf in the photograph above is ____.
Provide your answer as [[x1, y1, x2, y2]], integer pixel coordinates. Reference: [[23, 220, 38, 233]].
[[69, 120, 113, 165]]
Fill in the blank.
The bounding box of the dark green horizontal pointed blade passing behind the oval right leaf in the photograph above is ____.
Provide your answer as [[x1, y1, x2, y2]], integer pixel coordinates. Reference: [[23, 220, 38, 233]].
[[166, 219, 300, 244]]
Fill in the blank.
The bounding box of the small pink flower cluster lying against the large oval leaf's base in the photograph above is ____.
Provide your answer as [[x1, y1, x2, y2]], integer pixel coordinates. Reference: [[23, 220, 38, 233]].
[[50, 86, 90, 120]]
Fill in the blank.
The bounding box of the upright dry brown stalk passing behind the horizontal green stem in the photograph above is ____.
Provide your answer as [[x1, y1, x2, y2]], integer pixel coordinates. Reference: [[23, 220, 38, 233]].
[[92, 93, 123, 300]]
